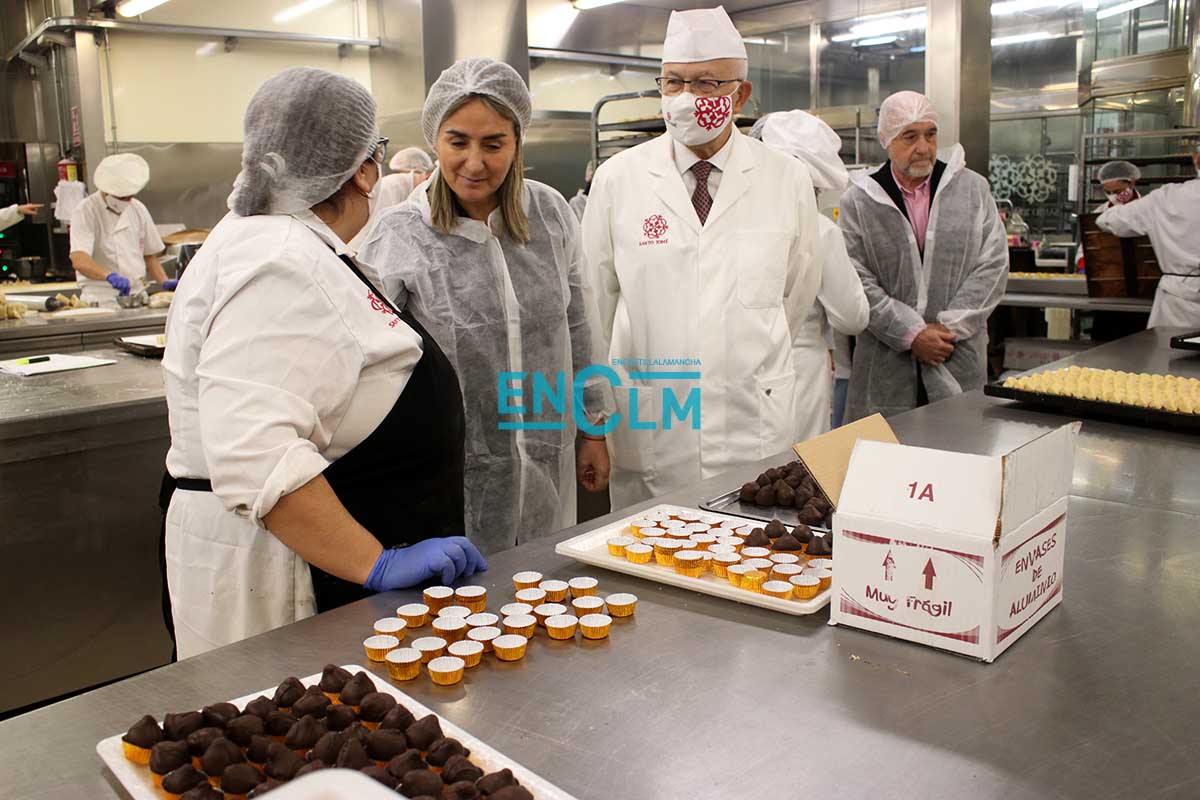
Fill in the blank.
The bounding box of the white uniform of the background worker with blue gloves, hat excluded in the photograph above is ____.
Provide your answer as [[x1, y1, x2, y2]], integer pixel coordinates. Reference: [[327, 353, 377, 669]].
[[71, 192, 167, 299]]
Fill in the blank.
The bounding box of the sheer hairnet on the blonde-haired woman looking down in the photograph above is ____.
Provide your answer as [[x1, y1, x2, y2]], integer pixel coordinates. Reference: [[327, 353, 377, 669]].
[[421, 59, 533, 148]]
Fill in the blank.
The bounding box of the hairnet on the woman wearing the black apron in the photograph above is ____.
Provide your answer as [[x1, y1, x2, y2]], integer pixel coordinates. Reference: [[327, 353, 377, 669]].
[[228, 67, 377, 217]]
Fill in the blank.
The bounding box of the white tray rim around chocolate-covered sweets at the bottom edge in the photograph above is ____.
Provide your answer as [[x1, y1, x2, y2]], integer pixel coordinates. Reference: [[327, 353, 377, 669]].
[[96, 664, 575, 800]]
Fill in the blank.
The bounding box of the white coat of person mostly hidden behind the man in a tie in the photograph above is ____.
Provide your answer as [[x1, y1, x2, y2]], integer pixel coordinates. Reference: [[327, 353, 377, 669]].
[[793, 215, 871, 441]]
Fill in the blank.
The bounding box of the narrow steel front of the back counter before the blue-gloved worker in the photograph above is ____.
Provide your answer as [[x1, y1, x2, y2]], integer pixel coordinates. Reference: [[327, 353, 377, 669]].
[[0, 309, 167, 360]]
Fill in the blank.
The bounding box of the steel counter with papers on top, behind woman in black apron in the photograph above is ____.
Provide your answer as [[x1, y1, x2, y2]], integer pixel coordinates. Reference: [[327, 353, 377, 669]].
[[0, 349, 170, 714]]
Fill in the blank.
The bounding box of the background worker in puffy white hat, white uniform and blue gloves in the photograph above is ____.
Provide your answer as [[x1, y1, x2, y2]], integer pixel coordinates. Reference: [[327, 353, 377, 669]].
[[71, 152, 174, 303]]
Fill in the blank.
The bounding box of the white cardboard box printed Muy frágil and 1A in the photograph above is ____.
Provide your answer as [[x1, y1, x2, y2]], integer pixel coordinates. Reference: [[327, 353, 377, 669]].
[[829, 422, 1080, 661]]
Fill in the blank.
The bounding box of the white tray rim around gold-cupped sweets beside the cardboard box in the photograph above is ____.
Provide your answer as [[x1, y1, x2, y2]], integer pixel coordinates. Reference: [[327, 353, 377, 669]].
[[554, 505, 830, 615]]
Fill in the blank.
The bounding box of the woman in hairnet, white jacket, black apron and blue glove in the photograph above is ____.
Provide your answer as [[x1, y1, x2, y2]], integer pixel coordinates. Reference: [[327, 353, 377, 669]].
[[162, 67, 486, 657]]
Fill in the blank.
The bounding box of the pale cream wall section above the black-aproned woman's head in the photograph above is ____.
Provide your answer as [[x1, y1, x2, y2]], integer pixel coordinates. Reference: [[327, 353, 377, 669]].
[[101, 0, 371, 143]]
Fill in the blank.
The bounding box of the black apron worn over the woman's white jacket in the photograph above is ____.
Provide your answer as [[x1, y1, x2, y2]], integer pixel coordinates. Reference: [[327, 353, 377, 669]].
[[158, 250, 467, 639]]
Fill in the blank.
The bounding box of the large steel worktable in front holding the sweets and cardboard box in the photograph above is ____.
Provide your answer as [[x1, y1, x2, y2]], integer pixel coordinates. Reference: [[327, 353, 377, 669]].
[[0, 333, 1200, 800]]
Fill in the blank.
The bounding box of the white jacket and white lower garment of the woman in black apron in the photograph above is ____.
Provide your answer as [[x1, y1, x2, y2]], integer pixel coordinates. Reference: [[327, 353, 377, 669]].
[[163, 211, 421, 657]]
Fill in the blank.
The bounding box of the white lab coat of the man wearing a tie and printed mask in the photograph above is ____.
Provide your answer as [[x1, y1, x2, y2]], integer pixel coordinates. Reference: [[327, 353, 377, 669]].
[[583, 131, 821, 510]]
